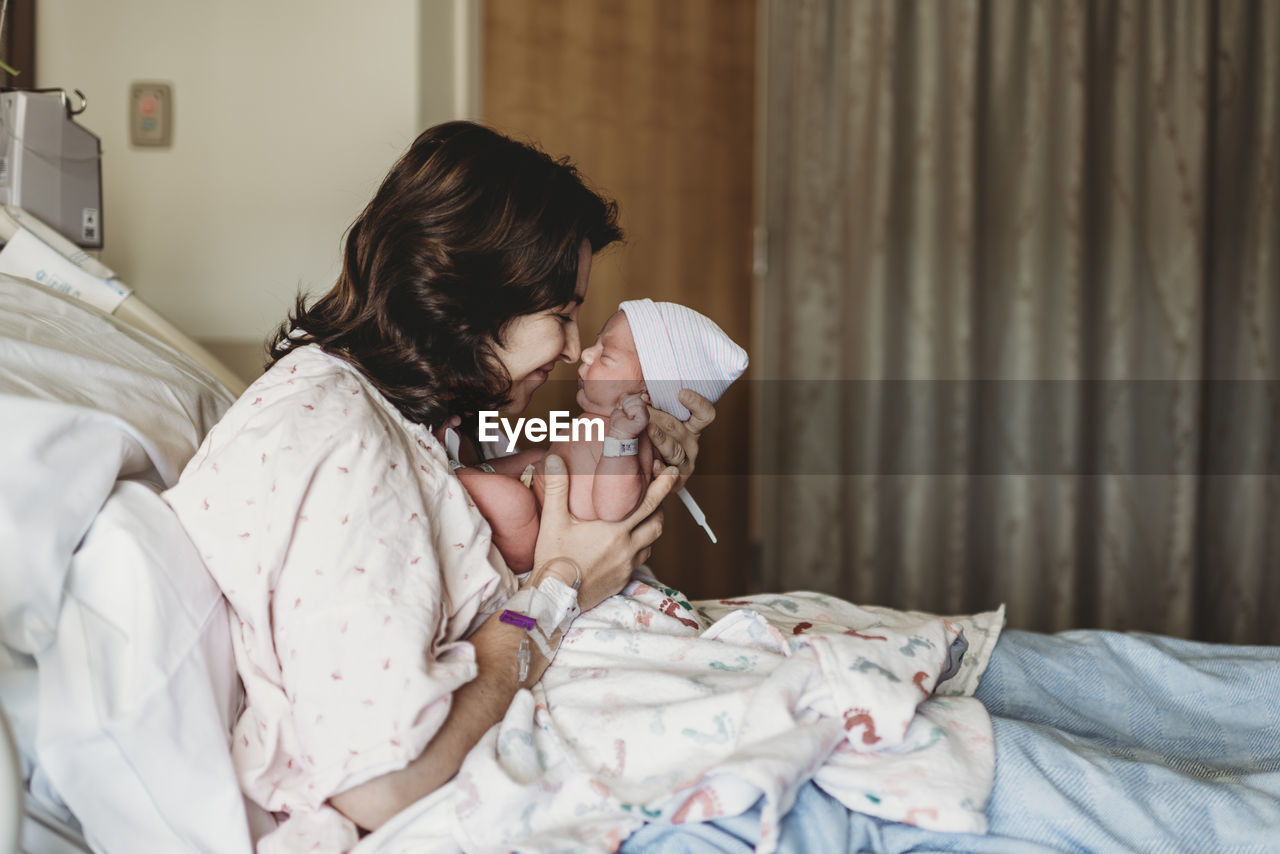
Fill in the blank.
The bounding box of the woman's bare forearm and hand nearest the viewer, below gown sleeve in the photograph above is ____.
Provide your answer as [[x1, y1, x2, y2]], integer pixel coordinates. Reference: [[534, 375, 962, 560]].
[[329, 455, 676, 830]]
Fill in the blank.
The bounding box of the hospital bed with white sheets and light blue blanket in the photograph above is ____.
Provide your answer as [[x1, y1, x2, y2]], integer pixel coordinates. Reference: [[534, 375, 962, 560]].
[[0, 210, 1280, 854]]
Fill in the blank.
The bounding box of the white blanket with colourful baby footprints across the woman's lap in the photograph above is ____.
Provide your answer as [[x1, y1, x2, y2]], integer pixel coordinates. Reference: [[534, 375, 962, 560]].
[[453, 580, 1004, 853]]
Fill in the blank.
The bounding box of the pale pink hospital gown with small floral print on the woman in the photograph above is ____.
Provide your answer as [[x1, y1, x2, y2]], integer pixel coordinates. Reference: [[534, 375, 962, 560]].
[[165, 346, 516, 850]]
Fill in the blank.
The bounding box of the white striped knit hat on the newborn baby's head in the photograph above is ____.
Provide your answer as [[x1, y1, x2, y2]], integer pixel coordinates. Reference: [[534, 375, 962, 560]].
[[618, 300, 748, 421]]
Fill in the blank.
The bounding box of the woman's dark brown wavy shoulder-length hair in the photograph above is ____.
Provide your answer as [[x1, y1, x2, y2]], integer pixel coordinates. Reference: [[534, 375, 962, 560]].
[[268, 122, 622, 425]]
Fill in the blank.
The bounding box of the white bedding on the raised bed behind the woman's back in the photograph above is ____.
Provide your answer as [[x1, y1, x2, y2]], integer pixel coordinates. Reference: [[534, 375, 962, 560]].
[[0, 277, 259, 854]]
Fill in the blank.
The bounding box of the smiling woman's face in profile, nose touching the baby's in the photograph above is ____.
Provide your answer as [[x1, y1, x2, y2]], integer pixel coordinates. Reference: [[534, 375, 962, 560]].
[[495, 241, 591, 414]]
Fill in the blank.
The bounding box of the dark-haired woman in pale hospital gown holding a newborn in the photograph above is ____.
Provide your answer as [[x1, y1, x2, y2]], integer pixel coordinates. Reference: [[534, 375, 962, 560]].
[[166, 122, 714, 848]]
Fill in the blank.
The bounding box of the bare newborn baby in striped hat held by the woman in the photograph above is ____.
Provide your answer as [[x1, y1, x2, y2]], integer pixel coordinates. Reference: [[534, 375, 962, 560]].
[[456, 300, 748, 572]]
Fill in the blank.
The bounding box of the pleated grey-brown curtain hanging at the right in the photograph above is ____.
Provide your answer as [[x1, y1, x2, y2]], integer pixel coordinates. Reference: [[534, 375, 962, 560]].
[[753, 0, 1280, 643]]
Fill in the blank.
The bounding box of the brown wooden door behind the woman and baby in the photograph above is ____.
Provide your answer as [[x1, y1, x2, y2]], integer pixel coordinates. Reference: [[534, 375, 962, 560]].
[[483, 0, 756, 598]]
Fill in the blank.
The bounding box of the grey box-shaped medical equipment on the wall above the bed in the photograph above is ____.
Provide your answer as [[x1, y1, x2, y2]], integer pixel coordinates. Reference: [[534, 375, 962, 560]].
[[0, 90, 102, 248]]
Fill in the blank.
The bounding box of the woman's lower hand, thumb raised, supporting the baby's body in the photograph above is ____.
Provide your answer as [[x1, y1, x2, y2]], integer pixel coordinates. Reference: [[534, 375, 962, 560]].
[[534, 453, 677, 611]]
